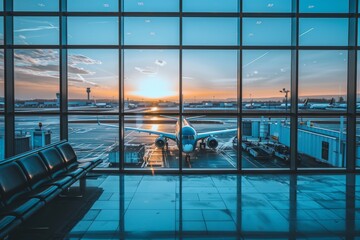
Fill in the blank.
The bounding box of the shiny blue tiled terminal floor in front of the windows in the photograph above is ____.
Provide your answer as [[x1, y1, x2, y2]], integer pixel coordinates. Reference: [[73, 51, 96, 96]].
[[11, 175, 360, 239]]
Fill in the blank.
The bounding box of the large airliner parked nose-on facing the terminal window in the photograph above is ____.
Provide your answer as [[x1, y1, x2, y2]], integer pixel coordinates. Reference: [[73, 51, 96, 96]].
[[98, 116, 237, 163]]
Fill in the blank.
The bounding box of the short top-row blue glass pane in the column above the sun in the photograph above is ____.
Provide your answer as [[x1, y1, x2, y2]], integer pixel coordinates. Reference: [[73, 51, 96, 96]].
[[123, 0, 179, 12]]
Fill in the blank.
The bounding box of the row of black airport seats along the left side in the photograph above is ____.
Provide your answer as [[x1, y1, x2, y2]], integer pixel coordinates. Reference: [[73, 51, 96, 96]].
[[0, 141, 101, 239]]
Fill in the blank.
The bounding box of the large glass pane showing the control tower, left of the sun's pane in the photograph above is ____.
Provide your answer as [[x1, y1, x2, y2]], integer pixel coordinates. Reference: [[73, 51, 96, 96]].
[[68, 49, 119, 112]]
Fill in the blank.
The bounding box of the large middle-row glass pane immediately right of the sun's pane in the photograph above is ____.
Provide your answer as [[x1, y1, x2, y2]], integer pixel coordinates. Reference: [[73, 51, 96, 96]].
[[182, 50, 238, 113]]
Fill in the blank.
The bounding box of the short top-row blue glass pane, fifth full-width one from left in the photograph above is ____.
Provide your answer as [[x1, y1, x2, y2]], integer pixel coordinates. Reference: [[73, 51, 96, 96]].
[[243, 0, 292, 12]]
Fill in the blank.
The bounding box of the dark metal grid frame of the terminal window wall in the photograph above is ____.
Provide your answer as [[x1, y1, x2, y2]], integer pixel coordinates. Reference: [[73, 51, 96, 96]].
[[0, 0, 360, 174]]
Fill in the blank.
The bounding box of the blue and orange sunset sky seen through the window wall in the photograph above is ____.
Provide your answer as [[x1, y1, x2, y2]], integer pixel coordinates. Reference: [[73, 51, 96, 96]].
[[0, 0, 358, 101]]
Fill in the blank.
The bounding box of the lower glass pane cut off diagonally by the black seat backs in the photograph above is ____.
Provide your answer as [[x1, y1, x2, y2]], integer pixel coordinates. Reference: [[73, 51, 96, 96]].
[[15, 115, 60, 154]]
